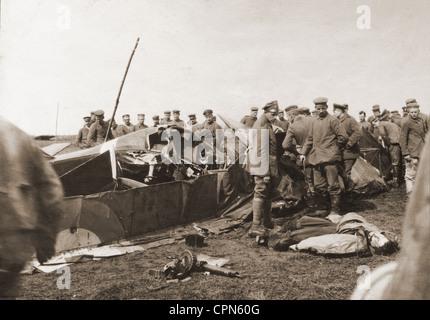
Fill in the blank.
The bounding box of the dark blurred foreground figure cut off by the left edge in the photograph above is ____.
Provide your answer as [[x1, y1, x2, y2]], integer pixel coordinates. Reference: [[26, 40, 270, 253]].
[[0, 117, 63, 299]]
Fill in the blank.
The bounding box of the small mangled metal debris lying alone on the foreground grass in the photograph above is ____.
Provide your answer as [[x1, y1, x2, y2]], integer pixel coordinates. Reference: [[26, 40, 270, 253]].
[[148, 250, 243, 290]]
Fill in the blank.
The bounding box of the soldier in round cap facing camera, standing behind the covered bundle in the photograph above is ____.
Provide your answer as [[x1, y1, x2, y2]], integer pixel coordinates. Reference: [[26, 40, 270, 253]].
[[300, 97, 348, 223]]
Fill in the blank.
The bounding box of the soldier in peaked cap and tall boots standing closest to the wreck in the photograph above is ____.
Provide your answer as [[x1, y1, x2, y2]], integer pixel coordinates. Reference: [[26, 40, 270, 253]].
[[246, 100, 279, 237]]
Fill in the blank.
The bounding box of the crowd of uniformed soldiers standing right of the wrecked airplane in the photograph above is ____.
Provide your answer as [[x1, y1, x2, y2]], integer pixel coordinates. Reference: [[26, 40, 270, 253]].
[[245, 97, 430, 236]]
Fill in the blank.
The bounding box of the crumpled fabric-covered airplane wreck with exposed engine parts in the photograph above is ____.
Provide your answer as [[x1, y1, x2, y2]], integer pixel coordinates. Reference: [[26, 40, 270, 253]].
[[50, 116, 383, 252]]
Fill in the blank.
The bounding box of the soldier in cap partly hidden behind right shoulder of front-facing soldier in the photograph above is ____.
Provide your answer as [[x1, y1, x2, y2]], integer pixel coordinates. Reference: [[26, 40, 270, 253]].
[[333, 103, 362, 197]]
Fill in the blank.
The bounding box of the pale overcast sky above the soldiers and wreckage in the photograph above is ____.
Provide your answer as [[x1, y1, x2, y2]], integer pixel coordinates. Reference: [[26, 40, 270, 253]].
[[0, 0, 430, 135]]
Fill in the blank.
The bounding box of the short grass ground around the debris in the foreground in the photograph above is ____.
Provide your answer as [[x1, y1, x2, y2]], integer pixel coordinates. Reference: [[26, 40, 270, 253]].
[[19, 182, 407, 300]]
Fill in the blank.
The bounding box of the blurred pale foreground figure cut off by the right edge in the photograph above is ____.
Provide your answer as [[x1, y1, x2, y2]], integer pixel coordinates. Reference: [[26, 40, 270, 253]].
[[351, 135, 430, 300]]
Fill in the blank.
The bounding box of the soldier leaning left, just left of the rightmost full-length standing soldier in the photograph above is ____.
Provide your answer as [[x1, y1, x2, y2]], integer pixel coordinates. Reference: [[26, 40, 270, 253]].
[[375, 110, 402, 188]]
